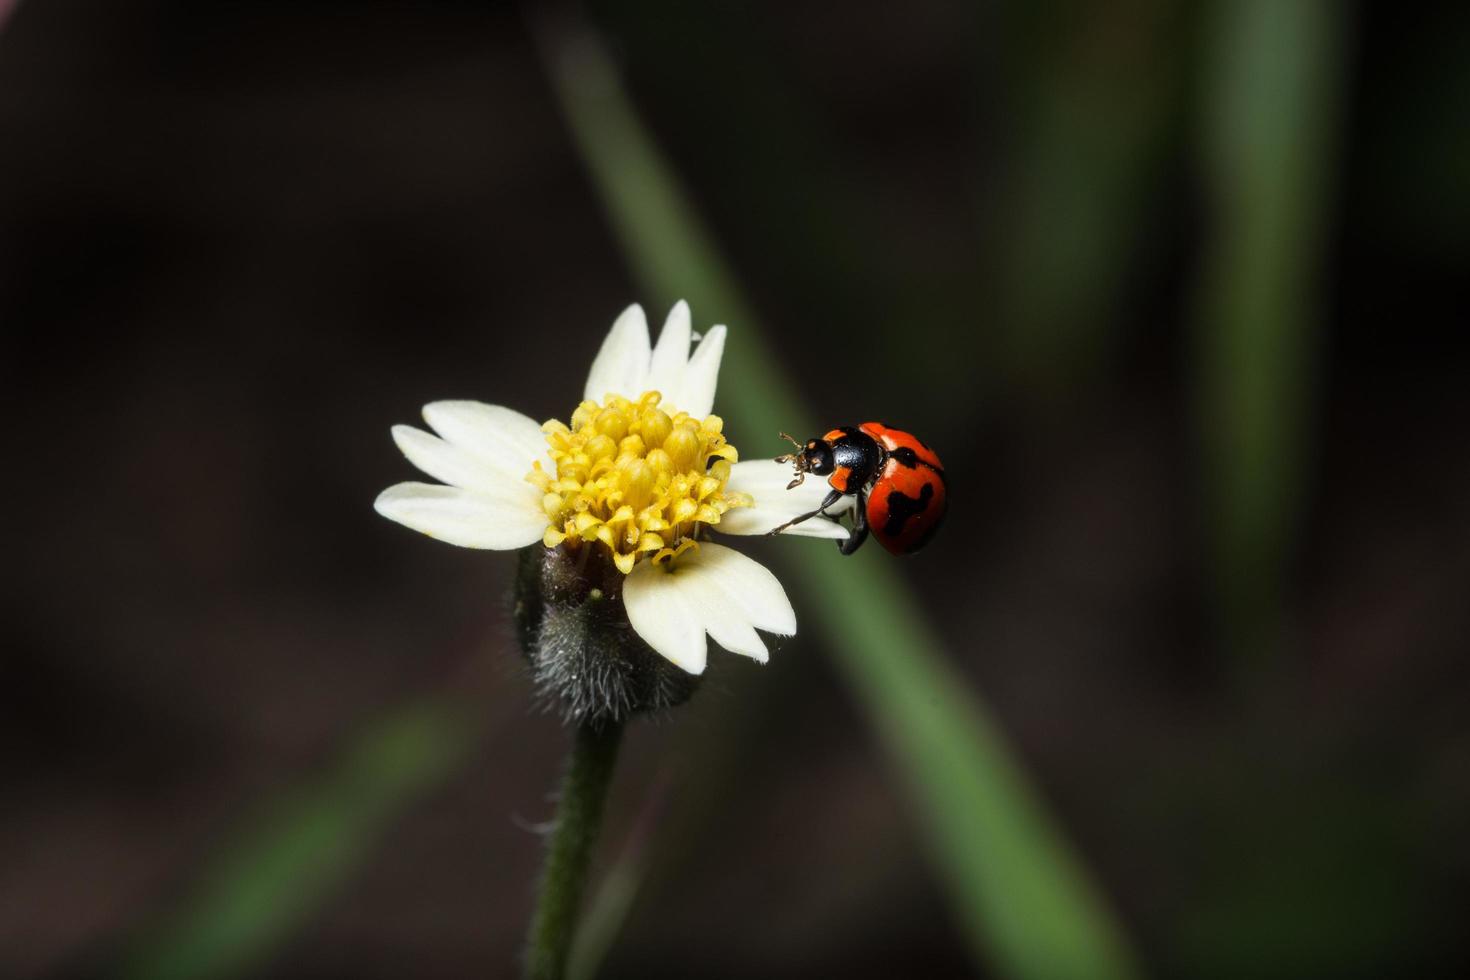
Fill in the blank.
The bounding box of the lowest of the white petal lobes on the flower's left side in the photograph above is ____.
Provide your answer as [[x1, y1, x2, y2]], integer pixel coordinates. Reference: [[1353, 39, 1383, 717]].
[[373, 483, 547, 551]]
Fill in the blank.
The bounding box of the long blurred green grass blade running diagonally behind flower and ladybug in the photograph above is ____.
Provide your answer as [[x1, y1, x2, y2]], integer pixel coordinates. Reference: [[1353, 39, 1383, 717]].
[[541, 26, 1138, 980]]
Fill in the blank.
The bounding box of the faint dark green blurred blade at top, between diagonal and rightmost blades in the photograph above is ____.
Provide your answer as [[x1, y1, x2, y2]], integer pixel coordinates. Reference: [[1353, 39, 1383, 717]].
[[980, 0, 1189, 407]]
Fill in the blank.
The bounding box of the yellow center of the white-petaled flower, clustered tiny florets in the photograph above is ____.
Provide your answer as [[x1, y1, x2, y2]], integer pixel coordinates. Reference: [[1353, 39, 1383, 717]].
[[526, 391, 753, 574]]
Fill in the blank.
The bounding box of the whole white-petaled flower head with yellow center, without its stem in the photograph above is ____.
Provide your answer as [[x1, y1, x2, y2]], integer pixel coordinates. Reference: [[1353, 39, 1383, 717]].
[[376, 301, 847, 674]]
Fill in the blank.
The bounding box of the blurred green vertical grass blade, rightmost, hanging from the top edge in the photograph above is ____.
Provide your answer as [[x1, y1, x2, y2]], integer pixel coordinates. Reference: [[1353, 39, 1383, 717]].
[[1197, 0, 1344, 663]]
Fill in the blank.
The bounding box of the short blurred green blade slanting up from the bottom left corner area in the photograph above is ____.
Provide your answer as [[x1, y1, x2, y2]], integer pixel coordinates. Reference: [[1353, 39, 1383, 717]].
[[121, 701, 476, 980]]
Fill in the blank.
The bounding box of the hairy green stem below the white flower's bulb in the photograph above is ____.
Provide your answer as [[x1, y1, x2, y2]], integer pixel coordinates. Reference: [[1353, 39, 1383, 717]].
[[526, 723, 623, 980]]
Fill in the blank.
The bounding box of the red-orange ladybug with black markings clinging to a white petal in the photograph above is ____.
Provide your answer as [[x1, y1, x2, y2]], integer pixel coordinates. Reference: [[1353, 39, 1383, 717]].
[[770, 422, 947, 555]]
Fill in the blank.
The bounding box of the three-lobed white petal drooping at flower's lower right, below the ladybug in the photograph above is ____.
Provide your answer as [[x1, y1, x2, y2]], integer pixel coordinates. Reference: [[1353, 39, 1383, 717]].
[[623, 542, 797, 673]]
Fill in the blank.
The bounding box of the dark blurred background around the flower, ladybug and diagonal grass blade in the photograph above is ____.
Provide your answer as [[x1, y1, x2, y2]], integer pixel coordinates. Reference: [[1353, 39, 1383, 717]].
[[0, 0, 1470, 977]]
